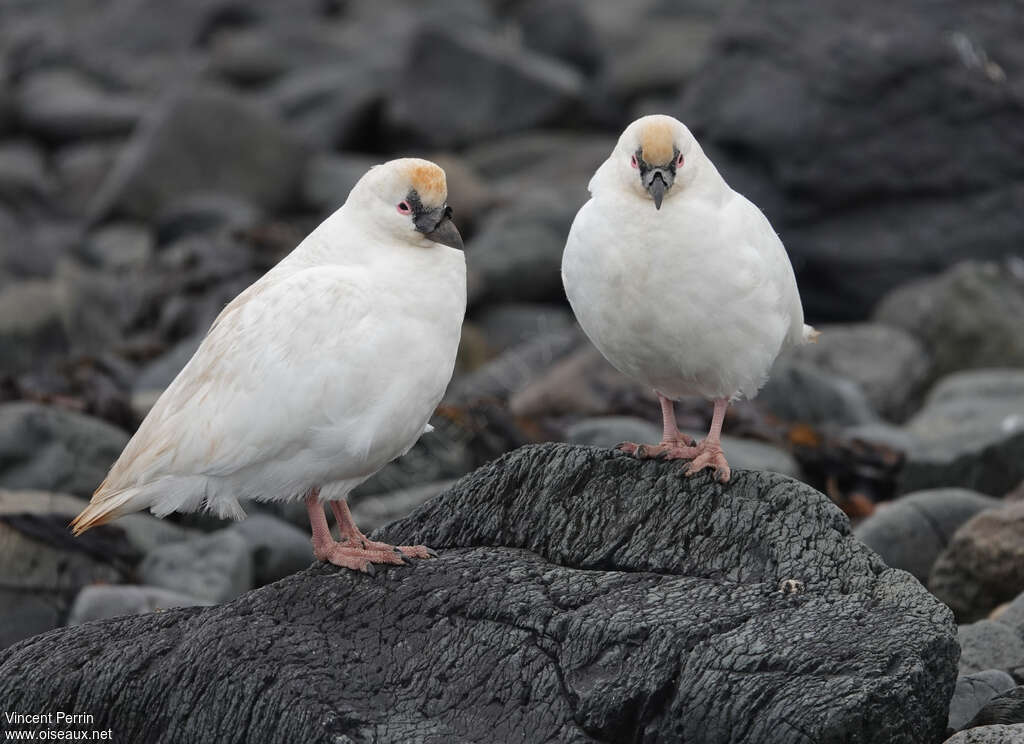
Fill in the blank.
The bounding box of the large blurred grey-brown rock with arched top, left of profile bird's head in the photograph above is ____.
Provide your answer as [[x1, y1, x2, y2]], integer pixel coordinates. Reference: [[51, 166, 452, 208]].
[[93, 89, 303, 220]]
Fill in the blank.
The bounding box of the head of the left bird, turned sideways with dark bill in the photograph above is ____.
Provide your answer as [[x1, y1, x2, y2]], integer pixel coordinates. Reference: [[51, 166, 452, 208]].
[[349, 158, 463, 251]]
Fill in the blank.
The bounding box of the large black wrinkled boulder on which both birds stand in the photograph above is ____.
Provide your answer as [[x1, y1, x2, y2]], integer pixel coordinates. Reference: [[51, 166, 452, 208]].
[[0, 444, 957, 744]]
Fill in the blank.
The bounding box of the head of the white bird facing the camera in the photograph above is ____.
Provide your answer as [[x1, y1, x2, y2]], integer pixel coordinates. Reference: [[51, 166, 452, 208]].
[[612, 115, 703, 210]]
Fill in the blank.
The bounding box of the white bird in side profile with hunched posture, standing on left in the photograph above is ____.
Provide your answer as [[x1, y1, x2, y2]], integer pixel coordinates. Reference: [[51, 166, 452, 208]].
[[73, 159, 466, 573]]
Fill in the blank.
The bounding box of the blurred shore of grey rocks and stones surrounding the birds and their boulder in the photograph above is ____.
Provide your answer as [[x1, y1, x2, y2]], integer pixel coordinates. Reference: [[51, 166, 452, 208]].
[[0, 0, 1024, 742]]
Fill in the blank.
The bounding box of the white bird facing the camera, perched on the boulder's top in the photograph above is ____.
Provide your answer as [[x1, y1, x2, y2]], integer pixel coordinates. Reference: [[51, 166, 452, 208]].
[[562, 116, 817, 481]]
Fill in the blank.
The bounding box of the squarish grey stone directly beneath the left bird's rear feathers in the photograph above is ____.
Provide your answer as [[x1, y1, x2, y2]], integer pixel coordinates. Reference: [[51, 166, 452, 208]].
[[138, 528, 253, 603]]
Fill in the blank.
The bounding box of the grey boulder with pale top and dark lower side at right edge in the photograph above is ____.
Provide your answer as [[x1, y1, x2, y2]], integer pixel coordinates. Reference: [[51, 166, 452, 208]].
[[899, 369, 1024, 496]]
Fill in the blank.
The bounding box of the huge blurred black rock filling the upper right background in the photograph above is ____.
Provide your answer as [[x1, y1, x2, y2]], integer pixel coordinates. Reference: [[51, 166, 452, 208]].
[[675, 0, 1024, 321]]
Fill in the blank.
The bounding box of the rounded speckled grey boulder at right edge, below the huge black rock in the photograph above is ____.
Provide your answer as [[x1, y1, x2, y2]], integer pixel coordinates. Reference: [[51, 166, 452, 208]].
[[874, 257, 1024, 378]]
